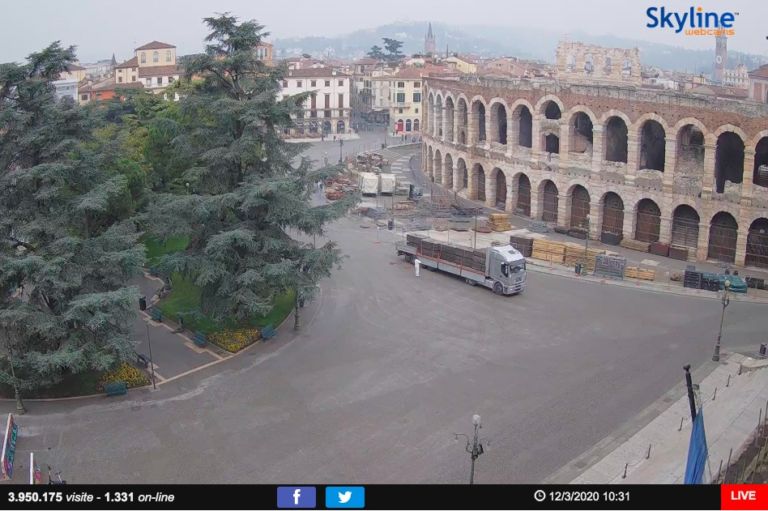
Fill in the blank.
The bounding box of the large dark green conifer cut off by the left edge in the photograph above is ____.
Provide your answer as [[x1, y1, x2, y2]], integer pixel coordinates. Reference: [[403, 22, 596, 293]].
[[0, 42, 144, 389]]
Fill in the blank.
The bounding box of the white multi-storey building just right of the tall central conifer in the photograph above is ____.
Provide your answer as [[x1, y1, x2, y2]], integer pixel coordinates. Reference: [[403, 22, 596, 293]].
[[280, 68, 352, 138]]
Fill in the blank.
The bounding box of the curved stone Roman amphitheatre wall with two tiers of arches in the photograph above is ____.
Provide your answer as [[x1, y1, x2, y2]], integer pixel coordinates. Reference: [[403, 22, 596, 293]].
[[422, 77, 768, 267]]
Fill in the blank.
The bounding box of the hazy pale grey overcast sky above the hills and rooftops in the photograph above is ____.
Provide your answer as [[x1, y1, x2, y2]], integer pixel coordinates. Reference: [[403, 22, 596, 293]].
[[0, 0, 768, 62]]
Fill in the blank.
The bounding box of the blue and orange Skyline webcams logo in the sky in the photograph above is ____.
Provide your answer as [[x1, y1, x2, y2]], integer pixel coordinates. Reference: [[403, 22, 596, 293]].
[[645, 6, 739, 36]]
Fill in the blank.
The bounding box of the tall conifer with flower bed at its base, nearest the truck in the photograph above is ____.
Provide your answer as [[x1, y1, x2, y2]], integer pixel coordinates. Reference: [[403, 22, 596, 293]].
[[147, 13, 351, 332]]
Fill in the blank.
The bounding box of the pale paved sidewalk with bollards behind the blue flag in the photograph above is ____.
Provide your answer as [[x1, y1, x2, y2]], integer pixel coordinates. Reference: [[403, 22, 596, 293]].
[[546, 353, 768, 484]]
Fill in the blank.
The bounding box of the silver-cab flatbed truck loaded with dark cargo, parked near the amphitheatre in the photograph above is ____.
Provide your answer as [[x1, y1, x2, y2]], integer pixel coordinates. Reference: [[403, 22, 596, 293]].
[[396, 234, 527, 295]]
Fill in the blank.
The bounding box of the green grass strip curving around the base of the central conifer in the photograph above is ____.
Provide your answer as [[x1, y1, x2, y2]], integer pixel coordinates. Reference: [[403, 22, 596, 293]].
[[156, 274, 294, 334]]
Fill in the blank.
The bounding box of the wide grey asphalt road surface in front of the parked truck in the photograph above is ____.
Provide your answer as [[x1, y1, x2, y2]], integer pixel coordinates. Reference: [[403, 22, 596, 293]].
[[0, 138, 765, 483]]
